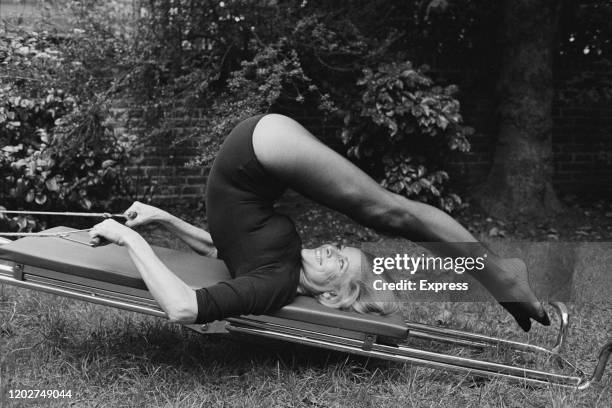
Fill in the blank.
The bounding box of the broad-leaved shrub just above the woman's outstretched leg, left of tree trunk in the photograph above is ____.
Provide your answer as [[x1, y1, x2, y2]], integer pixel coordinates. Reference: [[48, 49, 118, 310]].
[[343, 62, 472, 212]]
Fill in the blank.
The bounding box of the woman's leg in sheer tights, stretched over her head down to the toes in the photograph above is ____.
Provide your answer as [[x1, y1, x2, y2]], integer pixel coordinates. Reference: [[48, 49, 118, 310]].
[[253, 115, 549, 330]]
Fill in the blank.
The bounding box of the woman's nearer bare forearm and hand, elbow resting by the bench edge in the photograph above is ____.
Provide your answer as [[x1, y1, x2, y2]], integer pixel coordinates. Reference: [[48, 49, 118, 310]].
[[90, 220, 198, 324]]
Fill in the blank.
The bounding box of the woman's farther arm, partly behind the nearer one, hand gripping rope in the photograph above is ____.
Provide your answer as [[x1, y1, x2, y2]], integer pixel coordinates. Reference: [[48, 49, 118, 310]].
[[125, 201, 217, 258]]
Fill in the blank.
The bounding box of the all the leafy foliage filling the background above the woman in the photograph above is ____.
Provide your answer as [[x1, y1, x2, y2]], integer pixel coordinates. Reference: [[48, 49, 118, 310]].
[[0, 0, 612, 223]]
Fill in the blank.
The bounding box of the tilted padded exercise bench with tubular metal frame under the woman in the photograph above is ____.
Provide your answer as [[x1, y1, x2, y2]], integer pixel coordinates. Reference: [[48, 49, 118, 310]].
[[0, 227, 612, 389]]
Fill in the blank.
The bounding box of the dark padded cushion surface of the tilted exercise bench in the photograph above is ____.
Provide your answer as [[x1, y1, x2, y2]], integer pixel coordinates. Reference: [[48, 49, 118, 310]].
[[0, 227, 407, 338]]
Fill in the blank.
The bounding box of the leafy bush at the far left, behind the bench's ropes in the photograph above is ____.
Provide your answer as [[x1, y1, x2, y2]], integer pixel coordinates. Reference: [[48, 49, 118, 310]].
[[0, 27, 139, 230]]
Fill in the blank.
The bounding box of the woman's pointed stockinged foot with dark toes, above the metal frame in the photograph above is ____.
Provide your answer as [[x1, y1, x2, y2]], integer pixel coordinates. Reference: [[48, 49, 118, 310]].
[[481, 258, 550, 331]]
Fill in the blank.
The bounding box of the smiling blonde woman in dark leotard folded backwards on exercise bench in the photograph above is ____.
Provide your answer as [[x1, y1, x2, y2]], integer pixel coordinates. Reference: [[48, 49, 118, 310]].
[[91, 114, 550, 331]]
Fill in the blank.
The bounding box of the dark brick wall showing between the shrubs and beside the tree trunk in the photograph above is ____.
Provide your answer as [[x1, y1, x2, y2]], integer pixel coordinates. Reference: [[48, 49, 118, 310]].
[[120, 71, 612, 204]]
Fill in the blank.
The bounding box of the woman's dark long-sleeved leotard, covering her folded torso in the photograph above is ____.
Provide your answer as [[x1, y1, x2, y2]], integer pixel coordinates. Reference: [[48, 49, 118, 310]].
[[196, 115, 302, 323]]
